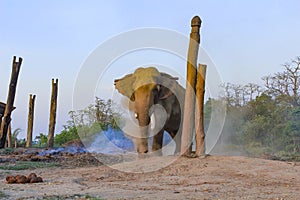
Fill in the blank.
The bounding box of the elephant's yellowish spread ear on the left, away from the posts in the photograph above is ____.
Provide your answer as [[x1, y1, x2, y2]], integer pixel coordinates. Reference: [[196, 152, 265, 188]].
[[115, 74, 135, 101]]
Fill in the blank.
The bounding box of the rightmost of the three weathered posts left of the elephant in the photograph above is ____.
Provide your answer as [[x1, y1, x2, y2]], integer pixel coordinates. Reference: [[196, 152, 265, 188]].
[[48, 79, 58, 148]]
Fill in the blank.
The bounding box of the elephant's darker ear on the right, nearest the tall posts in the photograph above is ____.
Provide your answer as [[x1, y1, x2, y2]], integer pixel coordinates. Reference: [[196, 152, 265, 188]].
[[157, 73, 178, 99]]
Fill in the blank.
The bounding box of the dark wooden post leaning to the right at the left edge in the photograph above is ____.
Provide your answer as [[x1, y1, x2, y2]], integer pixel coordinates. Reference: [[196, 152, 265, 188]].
[[0, 56, 23, 148]]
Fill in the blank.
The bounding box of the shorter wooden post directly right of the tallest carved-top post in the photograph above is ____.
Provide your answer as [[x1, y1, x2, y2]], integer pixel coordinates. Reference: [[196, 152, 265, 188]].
[[195, 64, 207, 156]]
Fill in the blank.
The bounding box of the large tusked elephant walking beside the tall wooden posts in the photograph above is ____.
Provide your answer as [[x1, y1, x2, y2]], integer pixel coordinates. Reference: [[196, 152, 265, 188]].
[[114, 67, 185, 155]]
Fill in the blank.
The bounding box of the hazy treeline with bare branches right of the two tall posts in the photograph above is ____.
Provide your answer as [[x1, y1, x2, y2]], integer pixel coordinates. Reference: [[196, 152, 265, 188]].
[[205, 57, 300, 160]]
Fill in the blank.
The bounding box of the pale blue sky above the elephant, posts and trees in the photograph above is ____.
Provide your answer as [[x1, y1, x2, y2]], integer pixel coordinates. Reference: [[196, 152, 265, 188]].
[[0, 0, 300, 137]]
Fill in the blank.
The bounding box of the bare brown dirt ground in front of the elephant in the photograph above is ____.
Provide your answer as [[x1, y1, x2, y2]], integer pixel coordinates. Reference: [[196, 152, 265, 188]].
[[0, 151, 300, 200]]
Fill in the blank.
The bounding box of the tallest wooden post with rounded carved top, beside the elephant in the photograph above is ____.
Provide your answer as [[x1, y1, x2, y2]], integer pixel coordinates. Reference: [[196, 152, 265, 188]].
[[181, 16, 201, 156]]
